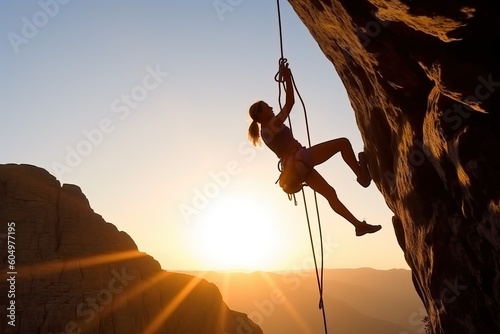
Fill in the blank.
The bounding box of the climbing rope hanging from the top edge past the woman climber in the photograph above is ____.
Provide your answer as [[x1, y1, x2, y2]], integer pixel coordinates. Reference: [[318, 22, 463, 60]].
[[274, 0, 328, 334]]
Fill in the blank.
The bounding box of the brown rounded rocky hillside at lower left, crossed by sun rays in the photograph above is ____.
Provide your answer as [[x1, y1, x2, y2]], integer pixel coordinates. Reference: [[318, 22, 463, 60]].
[[0, 165, 262, 334]]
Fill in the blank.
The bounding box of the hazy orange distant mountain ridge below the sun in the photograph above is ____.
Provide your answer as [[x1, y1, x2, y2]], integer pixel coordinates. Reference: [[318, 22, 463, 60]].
[[189, 268, 426, 334]]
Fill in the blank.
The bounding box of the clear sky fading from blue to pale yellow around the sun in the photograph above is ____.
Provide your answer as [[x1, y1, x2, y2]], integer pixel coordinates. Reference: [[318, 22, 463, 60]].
[[0, 0, 408, 270]]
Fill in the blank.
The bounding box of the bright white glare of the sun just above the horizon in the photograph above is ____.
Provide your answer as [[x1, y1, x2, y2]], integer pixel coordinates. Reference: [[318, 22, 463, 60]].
[[195, 196, 281, 270]]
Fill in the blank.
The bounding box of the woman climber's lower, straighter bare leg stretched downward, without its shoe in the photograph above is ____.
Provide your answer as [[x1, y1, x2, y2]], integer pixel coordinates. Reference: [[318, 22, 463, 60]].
[[305, 169, 364, 227]]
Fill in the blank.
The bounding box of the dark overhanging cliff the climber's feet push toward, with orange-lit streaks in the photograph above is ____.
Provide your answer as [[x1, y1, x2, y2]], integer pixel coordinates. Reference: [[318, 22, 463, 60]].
[[289, 0, 500, 334]]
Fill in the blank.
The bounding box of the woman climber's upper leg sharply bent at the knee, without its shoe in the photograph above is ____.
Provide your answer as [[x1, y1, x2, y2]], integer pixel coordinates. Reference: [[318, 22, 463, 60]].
[[308, 138, 362, 180]]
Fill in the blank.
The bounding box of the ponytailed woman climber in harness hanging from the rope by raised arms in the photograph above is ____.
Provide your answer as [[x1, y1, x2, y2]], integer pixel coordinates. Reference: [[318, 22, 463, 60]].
[[248, 63, 382, 236]]
